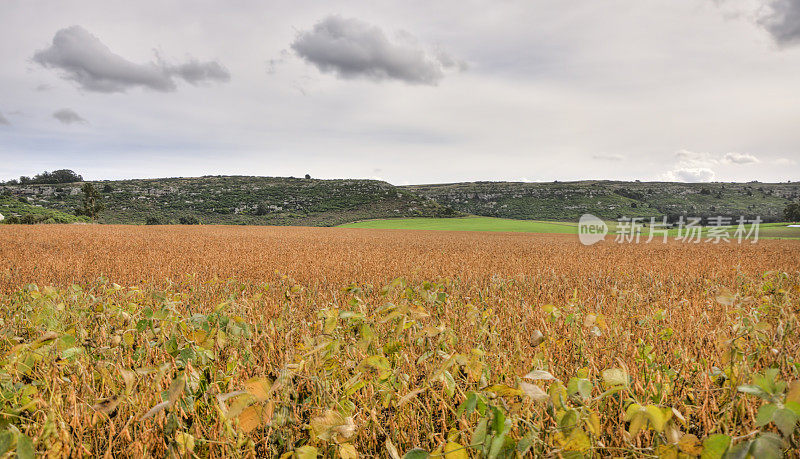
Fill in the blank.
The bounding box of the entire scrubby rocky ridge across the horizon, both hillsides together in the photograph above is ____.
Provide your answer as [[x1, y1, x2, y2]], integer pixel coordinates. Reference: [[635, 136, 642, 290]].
[[0, 169, 800, 226]]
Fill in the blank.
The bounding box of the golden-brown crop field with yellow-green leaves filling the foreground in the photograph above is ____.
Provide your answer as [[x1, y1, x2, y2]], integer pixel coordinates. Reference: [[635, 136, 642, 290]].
[[0, 225, 800, 459]]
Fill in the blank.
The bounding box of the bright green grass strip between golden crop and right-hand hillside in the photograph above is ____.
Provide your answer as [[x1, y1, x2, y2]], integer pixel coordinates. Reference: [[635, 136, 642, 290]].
[[341, 217, 800, 239]]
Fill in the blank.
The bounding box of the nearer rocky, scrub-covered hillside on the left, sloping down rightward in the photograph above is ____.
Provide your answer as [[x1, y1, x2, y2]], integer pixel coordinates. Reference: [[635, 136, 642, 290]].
[[0, 176, 457, 226]]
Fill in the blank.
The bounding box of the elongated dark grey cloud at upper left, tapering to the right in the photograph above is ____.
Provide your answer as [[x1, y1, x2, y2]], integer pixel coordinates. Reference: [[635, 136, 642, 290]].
[[33, 25, 230, 92]]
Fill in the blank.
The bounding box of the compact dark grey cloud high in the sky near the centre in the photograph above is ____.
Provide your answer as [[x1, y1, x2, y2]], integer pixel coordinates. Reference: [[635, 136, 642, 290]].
[[291, 16, 465, 85]]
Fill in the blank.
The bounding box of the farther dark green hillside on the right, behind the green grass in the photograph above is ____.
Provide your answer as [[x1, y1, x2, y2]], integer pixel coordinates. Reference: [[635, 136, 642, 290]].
[[401, 181, 800, 221]]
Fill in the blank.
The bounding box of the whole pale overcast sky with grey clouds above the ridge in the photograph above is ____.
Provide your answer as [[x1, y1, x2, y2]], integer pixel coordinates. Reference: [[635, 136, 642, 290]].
[[0, 0, 800, 184]]
